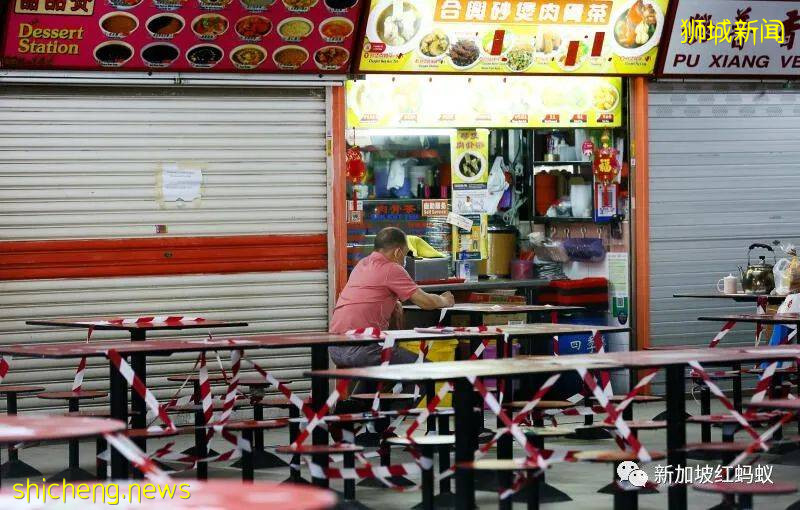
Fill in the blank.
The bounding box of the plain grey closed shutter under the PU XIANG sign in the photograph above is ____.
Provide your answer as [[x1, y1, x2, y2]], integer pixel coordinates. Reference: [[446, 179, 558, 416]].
[[649, 82, 800, 394]]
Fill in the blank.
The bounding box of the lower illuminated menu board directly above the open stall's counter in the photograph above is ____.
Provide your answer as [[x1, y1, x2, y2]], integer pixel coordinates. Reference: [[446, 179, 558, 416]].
[[347, 75, 622, 128]]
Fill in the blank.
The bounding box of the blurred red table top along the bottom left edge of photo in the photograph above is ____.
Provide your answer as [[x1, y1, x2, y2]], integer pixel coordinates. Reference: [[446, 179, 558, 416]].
[[0, 480, 336, 510]]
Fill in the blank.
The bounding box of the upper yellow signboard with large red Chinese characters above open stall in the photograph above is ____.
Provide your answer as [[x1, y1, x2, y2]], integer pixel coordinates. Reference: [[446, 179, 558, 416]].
[[359, 0, 669, 75]]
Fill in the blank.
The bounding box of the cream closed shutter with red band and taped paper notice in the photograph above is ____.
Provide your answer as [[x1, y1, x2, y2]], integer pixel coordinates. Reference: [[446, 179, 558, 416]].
[[0, 86, 328, 407]]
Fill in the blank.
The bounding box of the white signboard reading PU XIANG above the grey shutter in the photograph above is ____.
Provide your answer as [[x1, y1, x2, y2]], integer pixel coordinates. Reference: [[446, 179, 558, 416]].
[[660, 0, 800, 78]]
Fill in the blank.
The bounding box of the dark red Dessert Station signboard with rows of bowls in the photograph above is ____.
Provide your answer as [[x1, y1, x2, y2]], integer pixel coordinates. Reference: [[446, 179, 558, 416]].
[[2, 0, 367, 73]]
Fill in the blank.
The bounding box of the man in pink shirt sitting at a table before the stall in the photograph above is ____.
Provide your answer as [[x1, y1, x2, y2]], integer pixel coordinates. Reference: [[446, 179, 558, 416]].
[[329, 227, 454, 367]]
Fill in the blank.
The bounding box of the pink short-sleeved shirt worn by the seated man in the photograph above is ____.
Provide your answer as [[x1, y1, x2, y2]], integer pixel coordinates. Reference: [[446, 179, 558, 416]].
[[330, 251, 419, 333]]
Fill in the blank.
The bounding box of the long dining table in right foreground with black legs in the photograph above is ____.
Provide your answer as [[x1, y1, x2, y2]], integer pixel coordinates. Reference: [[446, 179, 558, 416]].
[[307, 346, 800, 510]]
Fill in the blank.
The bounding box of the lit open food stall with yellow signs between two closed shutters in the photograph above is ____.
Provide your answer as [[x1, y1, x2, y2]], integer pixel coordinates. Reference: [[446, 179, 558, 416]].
[[345, 0, 668, 366]]
